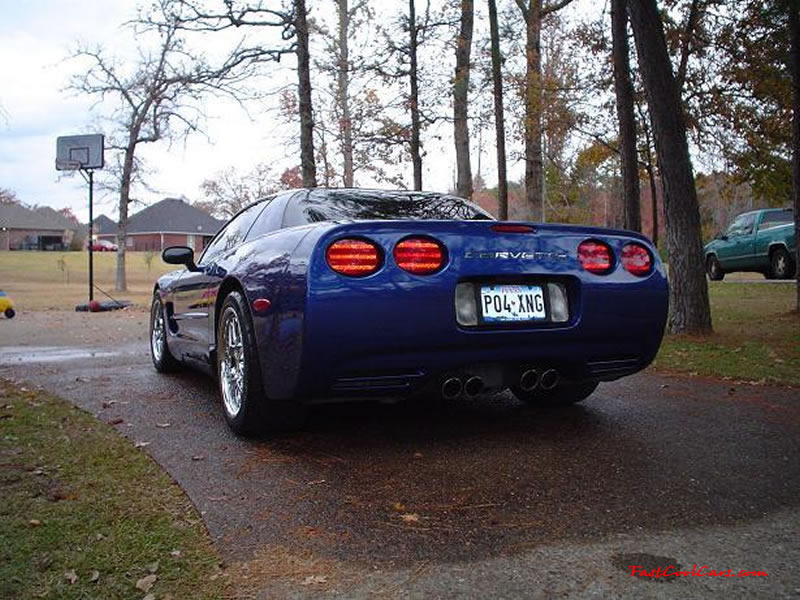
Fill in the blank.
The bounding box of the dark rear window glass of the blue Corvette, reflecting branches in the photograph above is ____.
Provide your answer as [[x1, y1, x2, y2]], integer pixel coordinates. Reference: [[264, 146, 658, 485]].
[[284, 190, 493, 227]]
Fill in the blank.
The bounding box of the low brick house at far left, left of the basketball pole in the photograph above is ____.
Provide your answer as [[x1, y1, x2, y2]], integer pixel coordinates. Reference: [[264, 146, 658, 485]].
[[0, 203, 78, 250]]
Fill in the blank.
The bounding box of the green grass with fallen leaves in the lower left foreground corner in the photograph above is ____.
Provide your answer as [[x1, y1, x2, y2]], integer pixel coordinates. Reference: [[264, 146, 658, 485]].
[[0, 379, 226, 599]]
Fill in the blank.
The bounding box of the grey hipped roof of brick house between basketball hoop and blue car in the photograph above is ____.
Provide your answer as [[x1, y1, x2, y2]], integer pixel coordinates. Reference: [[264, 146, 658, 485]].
[[127, 198, 225, 235]]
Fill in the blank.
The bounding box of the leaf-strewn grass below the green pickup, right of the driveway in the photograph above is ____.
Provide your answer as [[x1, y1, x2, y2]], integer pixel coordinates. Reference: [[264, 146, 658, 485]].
[[655, 282, 800, 386]]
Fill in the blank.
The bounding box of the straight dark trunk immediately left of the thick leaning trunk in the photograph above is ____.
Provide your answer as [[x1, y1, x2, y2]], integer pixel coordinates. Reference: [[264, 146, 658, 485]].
[[611, 0, 642, 231]]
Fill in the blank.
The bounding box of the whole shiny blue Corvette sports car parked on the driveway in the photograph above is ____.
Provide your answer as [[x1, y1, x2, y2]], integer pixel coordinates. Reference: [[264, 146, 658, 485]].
[[150, 189, 667, 435]]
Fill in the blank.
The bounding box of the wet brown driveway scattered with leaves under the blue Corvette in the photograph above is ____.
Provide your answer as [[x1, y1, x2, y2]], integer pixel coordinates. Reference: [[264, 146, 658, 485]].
[[0, 311, 800, 598]]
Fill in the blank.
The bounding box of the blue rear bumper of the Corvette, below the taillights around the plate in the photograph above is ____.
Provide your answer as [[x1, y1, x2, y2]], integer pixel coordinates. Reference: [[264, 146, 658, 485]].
[[293, 281, 667, 399]]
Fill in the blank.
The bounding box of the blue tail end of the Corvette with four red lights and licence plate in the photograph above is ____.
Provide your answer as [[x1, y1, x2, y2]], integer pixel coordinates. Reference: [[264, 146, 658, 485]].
[[288, 221, 668, 398]]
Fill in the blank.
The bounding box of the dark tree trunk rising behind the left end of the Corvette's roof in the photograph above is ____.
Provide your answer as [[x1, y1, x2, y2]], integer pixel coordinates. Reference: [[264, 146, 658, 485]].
[[295, 0, 317, 187]]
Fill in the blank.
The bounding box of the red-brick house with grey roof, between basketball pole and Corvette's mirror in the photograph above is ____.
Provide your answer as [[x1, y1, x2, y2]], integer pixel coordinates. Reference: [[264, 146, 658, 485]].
[[94, 198, 225, 252]]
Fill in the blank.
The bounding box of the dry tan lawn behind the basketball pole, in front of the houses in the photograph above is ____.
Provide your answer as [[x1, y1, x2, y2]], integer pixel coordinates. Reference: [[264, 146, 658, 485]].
[[0, 251, 176, 311]]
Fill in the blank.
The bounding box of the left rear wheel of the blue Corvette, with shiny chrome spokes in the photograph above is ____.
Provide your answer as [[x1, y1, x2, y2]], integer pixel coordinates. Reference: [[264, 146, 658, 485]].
[[217, 291, 305, 436]]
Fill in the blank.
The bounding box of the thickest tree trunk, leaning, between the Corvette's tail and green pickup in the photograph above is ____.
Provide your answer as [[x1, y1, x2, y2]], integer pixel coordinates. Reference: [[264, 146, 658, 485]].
[[628, 0, 711, 334]]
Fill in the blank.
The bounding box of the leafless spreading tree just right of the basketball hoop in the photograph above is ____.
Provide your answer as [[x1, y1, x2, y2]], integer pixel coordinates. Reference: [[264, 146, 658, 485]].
[[70, 19, 253, 291]]
